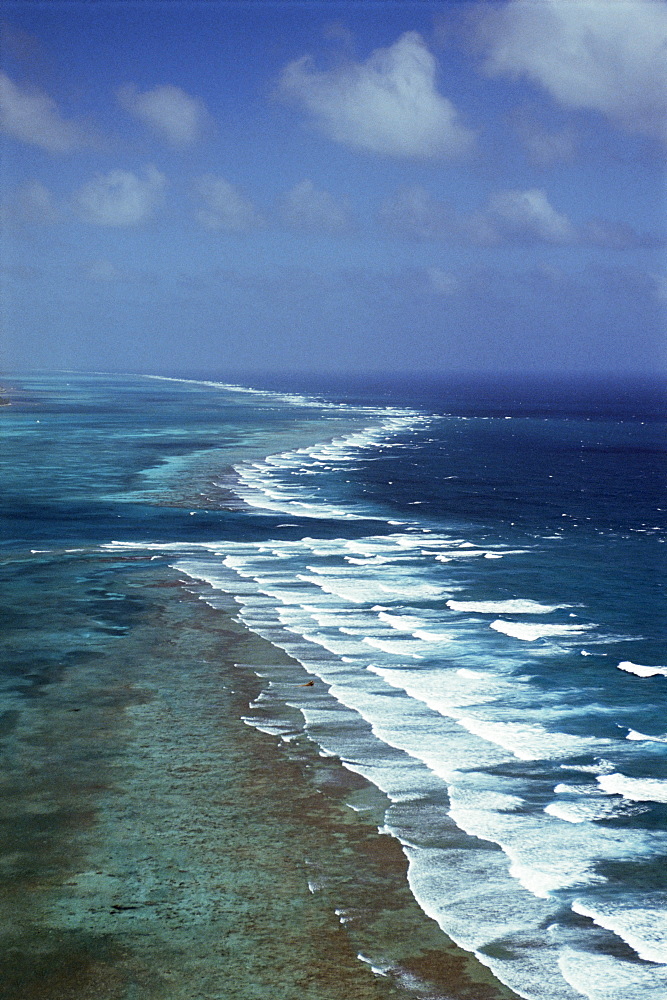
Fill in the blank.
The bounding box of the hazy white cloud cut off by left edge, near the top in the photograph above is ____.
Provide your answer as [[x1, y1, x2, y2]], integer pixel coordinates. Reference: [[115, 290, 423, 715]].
[[0, 73, 86, 153]]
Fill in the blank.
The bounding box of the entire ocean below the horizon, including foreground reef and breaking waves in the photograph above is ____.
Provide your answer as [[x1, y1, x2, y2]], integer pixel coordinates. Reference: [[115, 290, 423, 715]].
[[0, 373, 667, 1000]]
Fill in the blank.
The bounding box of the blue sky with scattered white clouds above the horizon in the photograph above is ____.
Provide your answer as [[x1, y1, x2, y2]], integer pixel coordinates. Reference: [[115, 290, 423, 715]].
[[0, 0, 667, 376]]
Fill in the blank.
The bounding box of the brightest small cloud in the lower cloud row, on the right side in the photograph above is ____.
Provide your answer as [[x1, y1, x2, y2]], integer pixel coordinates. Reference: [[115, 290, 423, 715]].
[[487, 188, 577, 244]]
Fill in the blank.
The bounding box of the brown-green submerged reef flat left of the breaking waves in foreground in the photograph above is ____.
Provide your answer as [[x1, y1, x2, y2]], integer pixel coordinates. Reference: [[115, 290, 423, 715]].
[[0, 551, 514, 1000]]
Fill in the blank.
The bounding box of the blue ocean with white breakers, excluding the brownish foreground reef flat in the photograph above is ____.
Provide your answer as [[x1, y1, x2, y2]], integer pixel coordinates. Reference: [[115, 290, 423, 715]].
[[0, 374, 667, 1000]]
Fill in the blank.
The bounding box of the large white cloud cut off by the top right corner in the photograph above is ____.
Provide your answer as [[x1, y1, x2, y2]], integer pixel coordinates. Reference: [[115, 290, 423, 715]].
[[478, 0, 667, 138]]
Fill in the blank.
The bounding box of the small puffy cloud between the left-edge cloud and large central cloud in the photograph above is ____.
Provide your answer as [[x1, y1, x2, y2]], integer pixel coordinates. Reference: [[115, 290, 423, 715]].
[[118, 84, 207, 148]]
